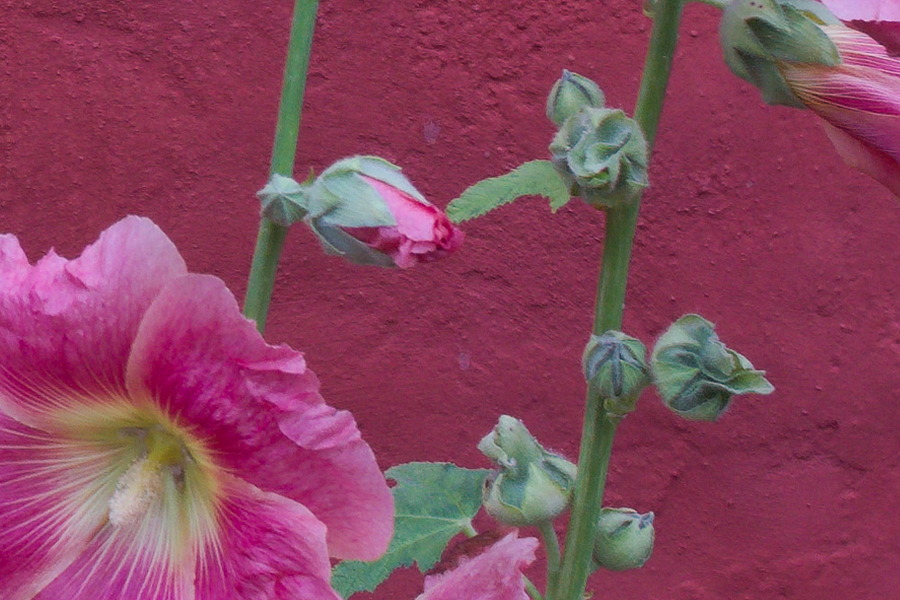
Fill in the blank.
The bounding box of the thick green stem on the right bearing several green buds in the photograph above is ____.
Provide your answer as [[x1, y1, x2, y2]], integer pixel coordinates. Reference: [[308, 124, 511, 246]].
[[548, 0, 683, 600]]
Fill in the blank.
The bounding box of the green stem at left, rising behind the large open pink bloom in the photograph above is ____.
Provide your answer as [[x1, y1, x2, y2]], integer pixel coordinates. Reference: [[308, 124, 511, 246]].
[[244, 0, 319, 332]]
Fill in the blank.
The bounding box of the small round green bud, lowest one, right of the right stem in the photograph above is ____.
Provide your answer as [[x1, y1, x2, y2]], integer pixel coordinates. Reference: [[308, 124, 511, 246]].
[[593, 508, 654, 571]]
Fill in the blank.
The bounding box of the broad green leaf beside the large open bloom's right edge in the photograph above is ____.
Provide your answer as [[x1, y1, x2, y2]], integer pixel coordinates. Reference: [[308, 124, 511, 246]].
[[331, 462, 490, 598]]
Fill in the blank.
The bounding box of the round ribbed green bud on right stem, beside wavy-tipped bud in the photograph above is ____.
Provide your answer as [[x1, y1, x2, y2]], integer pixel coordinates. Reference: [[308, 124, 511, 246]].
[[581, 331, 650, 416]]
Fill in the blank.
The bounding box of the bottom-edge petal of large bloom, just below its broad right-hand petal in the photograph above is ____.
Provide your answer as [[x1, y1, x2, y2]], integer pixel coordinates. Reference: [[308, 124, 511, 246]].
[[196, 477, 340, 600]]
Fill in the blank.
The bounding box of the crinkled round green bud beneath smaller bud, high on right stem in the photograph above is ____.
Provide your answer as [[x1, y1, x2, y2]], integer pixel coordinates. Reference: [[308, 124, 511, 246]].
[[550, 107, 648, 208]]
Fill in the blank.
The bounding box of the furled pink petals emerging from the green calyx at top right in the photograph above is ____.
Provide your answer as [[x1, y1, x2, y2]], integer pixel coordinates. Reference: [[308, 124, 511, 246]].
[[779, 25, 900, 196]]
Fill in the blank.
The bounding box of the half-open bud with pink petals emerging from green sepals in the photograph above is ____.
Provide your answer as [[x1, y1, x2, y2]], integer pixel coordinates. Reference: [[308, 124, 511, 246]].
[[304, 156, 464, 268]]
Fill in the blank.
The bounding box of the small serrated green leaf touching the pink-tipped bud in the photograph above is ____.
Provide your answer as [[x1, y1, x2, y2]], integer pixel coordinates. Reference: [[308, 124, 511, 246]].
[[447, 160, 571, 223]]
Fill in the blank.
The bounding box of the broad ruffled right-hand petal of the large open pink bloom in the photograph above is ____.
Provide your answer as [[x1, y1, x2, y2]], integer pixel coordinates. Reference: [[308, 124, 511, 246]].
[[128, 275, 393, 560]]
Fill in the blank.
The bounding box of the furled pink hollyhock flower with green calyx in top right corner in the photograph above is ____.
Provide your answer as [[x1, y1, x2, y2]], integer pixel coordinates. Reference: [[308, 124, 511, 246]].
[[721, 0, 900, 196]]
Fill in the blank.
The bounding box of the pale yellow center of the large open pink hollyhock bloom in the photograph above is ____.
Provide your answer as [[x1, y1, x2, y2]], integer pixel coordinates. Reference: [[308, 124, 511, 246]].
[[51, 395, 223, 564]]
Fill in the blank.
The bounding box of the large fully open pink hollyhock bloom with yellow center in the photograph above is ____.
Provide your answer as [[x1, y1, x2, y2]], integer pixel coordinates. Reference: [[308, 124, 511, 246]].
[[0, 217, 392, 600]]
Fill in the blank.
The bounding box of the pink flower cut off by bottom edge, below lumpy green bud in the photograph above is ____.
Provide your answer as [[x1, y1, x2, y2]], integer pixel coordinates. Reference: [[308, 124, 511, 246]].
[[416, 533, 538, 600]]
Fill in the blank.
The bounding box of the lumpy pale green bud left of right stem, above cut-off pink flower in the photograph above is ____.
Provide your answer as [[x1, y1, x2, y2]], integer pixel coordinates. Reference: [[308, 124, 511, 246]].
[[478, 415, 577, 527]]
